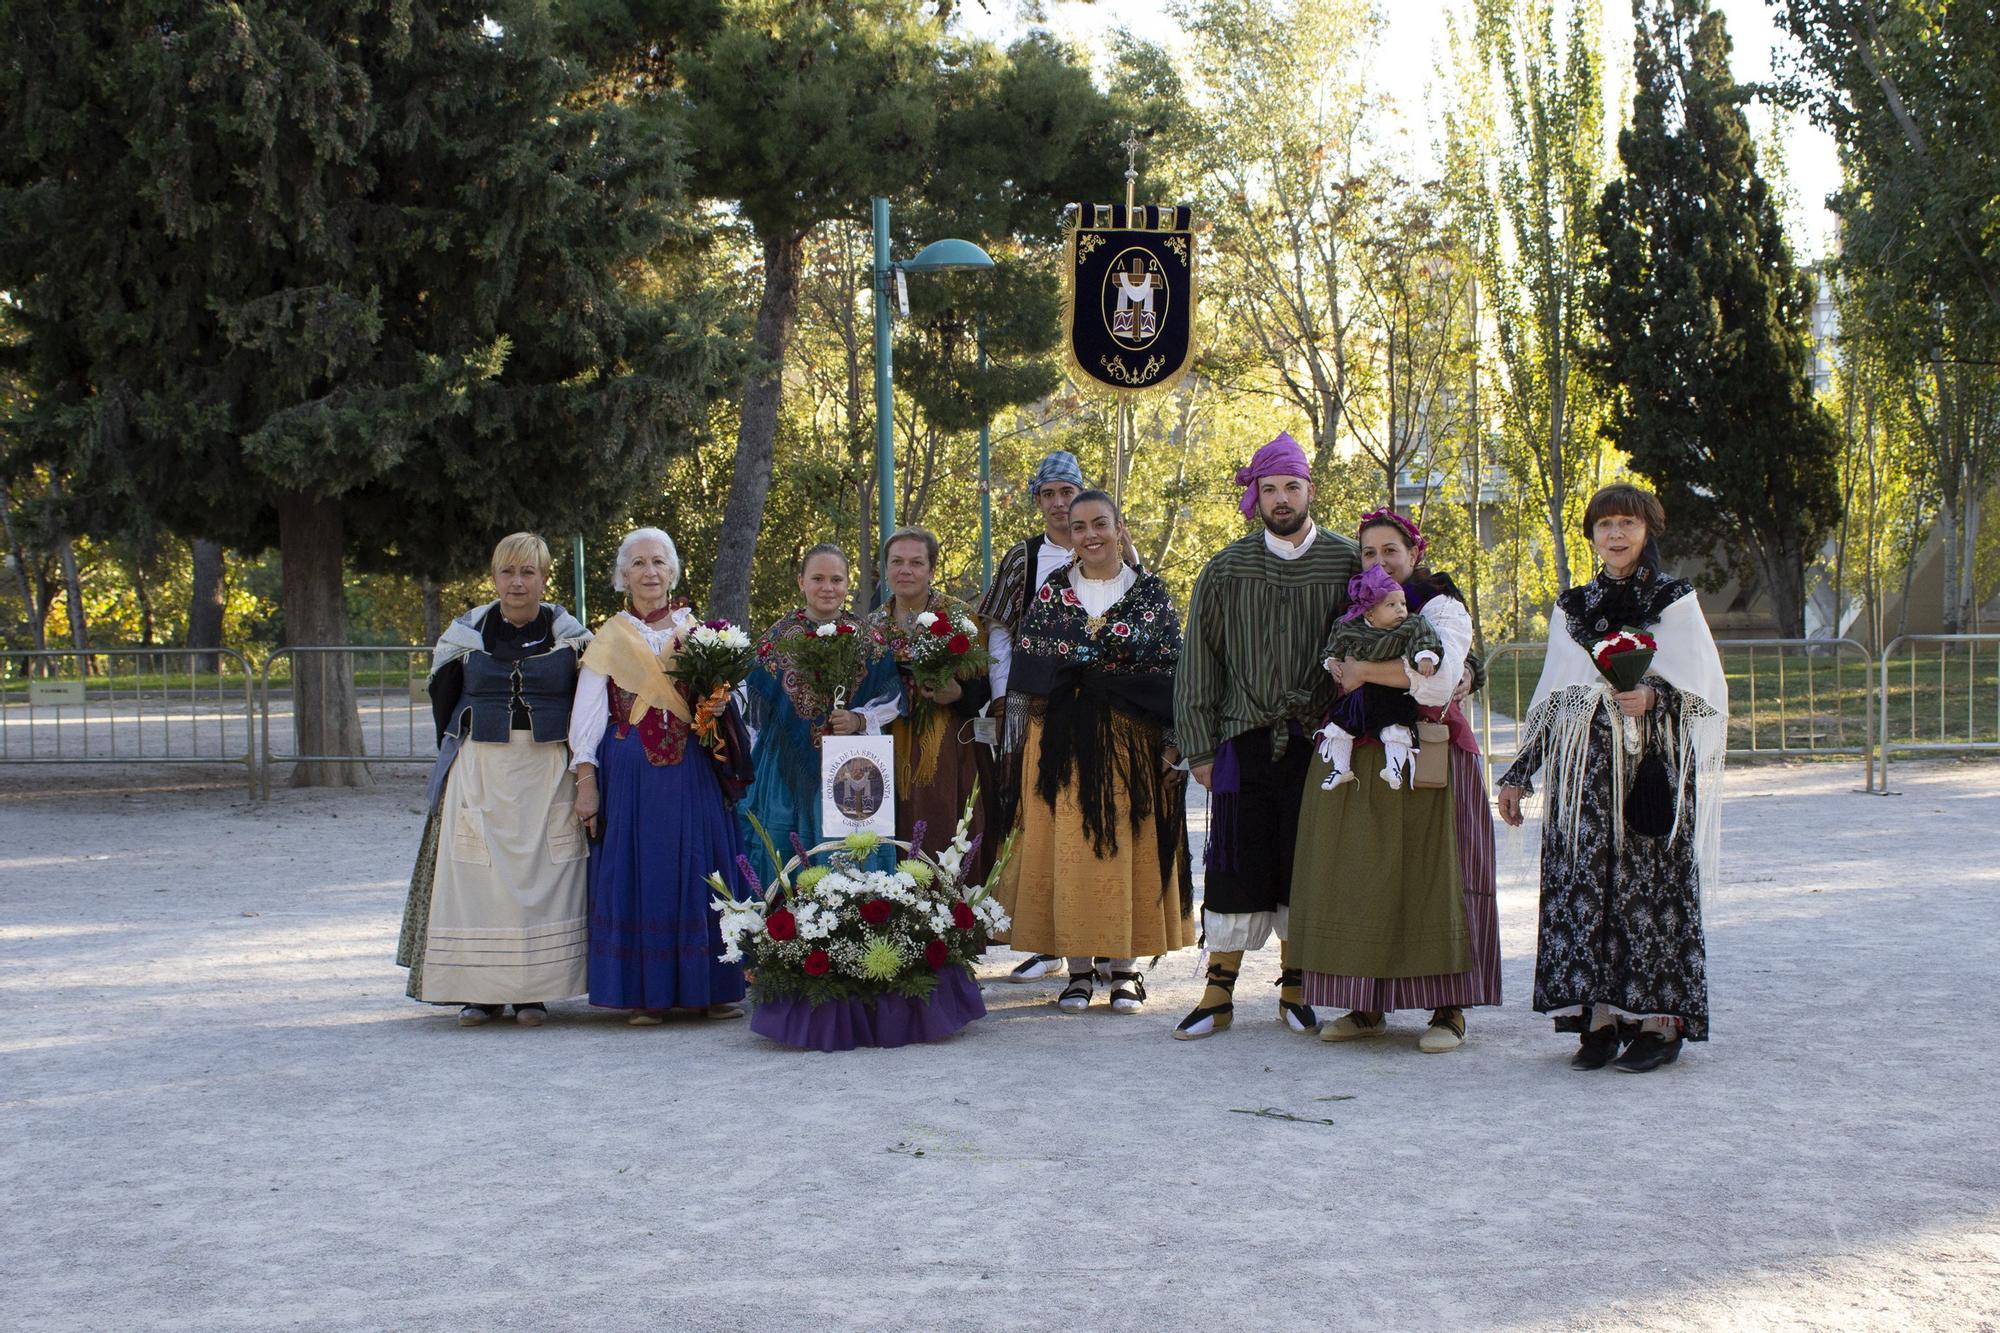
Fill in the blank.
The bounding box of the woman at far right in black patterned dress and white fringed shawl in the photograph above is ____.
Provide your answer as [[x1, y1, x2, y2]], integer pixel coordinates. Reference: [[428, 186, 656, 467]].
[[1498, 484, 1730, 1073]]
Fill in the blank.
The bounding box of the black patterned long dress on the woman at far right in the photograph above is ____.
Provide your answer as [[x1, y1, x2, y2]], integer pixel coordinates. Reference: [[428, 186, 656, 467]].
[[1500, 566, 1708, 1041]]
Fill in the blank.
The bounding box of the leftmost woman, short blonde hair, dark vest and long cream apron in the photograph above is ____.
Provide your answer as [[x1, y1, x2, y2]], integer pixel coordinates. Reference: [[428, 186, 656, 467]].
[[396, 532, 590, 1027]]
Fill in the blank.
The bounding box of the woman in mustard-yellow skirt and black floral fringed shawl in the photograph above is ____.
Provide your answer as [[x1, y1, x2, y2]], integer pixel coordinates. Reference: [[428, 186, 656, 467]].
[[1000, 490, 1194, 1013]]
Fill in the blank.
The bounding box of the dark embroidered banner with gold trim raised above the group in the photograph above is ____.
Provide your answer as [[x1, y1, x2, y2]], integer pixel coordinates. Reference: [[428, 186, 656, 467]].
[[1062, 204, 1194, 394]]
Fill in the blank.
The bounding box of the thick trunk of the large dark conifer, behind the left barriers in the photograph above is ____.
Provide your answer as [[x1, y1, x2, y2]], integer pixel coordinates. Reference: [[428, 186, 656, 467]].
[[278, 494, 370, 787]]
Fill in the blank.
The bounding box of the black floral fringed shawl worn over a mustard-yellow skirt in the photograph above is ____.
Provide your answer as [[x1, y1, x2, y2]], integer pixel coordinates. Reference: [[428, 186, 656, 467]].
[[1008, 564, 1194, 913]]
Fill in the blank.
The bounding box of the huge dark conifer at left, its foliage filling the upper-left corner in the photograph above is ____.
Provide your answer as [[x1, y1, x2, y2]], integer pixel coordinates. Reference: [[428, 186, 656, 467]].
[[0, 0, 728, 783]]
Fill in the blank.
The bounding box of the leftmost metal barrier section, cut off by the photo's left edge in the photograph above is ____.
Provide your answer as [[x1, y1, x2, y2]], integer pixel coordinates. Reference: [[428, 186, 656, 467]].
[[0, 648, 258, 797]]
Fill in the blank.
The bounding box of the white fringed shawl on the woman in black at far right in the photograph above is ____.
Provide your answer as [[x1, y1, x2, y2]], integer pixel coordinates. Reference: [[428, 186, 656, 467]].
[[1520, 592, 1730, 893]]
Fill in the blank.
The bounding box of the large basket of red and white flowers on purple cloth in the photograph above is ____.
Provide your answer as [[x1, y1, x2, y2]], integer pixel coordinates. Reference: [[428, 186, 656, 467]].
[[708, 791, 1012, 1005]]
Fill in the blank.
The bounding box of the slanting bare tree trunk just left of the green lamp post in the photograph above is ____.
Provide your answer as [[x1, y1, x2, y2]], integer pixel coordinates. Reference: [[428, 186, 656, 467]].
[[708, 232, 796, 624]]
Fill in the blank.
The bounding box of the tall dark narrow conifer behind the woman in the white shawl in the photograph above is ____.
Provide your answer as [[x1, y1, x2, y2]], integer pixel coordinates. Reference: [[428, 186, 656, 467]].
[[1596, 0, 1840, 636]]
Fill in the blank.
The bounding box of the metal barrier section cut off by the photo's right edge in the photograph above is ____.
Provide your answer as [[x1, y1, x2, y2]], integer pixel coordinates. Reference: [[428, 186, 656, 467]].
[[1874, 634, 2000, 797]]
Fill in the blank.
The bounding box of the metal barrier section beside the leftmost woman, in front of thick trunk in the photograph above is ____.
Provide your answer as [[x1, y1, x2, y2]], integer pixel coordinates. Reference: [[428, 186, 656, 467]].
[[258, 644, 438, 799]]
